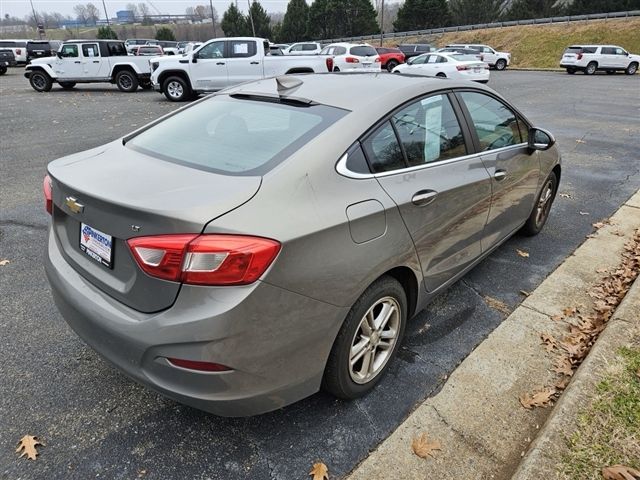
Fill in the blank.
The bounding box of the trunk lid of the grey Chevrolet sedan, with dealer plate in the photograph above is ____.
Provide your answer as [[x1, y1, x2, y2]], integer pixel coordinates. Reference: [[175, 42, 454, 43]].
[[48, 142, 261, 312]]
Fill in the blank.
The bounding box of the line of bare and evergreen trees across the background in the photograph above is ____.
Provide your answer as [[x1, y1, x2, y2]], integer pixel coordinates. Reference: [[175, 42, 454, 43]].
[[0, 0, 640, 42]]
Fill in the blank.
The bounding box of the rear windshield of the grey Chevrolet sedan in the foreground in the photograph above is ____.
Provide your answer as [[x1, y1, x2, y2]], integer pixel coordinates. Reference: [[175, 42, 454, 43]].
[[126, 95, 347, 175]]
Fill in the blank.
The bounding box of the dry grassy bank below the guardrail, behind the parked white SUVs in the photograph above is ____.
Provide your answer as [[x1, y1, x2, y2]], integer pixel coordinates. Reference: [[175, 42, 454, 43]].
[[385, 18, 640, 68]]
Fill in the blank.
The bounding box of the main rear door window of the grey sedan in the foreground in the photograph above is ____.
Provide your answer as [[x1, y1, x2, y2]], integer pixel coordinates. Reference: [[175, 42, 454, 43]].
[[392, 95, 467, 167]]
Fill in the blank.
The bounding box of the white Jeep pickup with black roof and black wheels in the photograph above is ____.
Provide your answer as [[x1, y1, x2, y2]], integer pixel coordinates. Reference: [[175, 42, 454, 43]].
[[24, 40, 151, 92]]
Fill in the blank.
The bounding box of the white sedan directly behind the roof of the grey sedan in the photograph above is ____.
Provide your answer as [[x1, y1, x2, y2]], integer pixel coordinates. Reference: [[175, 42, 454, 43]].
[[393, 53, 490, 83]]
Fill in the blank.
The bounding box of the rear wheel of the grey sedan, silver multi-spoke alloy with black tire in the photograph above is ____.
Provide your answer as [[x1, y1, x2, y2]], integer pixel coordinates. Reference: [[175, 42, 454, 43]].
[[322, 276, 407, 399]]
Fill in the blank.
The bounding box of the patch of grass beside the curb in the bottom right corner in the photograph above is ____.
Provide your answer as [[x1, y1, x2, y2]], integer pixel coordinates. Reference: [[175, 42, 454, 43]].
[[559, 346, 640, 480]]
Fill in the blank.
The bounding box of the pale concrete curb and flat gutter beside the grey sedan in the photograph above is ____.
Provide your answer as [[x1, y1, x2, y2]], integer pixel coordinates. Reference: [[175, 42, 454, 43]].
[[347, 190, 640, 480]]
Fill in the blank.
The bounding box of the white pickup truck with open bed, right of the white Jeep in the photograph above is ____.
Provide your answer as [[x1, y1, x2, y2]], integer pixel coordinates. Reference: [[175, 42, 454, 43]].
[[151, 37, 330, 102]]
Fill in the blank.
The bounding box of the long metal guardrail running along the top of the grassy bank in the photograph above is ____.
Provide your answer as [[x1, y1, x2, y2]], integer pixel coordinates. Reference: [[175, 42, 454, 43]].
[[318, 10, 640, 43]]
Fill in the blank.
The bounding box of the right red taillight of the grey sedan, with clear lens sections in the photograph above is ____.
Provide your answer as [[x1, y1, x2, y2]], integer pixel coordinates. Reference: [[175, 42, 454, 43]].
[[127, 234, 280, 285]]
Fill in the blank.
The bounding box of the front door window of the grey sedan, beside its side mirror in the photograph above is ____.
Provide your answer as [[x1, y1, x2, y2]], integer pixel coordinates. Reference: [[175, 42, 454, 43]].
[[460, 92, 522, 151]]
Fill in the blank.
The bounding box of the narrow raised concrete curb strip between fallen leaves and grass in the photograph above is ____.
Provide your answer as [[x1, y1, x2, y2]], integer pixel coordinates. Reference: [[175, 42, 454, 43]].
[[512, 280, 640, 480]]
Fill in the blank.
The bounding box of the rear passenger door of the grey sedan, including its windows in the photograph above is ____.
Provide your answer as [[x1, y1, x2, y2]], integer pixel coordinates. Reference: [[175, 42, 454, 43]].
[[363, 95, 491, 291]]
